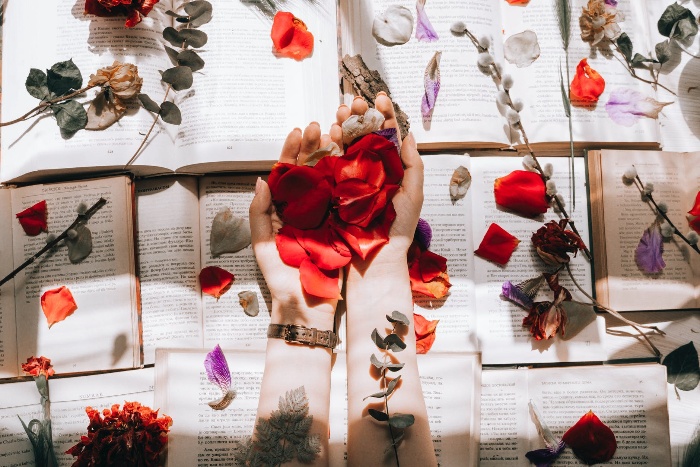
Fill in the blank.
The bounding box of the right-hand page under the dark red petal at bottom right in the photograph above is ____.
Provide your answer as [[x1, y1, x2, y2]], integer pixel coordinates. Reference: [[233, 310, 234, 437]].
[[532, 364, 671, 467]]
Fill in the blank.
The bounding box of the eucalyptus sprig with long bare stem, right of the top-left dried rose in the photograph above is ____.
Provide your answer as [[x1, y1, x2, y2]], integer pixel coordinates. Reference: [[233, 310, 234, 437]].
[[125, 0, 212, 167]]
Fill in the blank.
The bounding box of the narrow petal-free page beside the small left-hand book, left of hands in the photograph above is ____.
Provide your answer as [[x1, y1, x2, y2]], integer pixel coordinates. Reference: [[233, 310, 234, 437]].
[[136, 177, 203, 364]]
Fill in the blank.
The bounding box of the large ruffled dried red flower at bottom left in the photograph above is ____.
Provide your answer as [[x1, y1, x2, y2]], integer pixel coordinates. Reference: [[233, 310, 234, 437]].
[[66, 402, 173, 467]]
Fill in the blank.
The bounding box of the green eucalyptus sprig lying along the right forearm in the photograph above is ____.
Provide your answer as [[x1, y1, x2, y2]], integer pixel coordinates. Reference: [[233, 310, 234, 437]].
[[365, 311, 415, 466]]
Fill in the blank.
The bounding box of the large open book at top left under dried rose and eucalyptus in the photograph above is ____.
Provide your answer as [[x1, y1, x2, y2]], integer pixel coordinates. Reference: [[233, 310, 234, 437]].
[[0, 0, 340, 182]]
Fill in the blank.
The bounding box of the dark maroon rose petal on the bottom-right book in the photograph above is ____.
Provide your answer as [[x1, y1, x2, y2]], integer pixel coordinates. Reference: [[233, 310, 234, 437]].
[[562, 410, 617, 464]]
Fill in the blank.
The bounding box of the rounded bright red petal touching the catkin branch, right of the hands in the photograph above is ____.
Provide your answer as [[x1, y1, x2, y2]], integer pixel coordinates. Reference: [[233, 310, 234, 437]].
[[493, 170, 549, 217]]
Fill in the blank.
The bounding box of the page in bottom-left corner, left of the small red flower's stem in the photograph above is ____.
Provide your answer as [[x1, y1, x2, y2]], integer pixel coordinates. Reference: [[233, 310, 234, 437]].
[[0, 381, 41, 466]]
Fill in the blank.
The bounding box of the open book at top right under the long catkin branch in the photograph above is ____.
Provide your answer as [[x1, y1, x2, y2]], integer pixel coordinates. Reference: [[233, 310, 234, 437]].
[[340, 0, 700, 149]]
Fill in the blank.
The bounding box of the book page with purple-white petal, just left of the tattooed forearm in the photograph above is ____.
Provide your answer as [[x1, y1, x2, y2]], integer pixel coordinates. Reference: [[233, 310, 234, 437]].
[[155, 349, 265, 467]]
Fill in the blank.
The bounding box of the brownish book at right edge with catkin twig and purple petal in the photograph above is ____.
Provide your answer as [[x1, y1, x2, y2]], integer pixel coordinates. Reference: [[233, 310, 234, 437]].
[[588, 151, 700, 311]]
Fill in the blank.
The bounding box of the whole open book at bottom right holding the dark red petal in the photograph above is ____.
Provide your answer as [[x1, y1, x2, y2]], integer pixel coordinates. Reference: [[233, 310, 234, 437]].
[[479, 364, 671, 467]]
